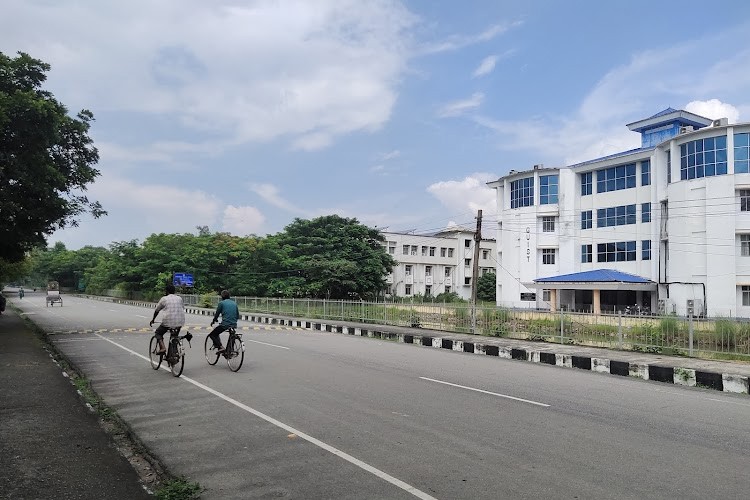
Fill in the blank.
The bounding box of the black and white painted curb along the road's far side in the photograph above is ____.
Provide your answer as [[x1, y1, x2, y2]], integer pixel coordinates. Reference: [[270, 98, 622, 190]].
[[82, 297, 750, 394]]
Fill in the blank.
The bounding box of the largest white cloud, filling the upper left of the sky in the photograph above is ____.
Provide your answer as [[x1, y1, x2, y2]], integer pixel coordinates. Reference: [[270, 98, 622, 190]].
[[0, 0, 417, 150]]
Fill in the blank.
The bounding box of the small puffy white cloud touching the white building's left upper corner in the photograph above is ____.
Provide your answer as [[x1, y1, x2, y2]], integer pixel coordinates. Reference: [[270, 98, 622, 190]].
[[427, 173, 498, 215]]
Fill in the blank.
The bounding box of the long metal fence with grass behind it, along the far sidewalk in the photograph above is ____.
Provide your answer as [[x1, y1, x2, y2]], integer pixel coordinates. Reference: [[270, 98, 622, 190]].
[[172, 295, 750, 360]]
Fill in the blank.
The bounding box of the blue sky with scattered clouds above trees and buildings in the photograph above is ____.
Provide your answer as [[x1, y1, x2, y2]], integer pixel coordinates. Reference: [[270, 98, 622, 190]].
[[0, 0, 750, 249]]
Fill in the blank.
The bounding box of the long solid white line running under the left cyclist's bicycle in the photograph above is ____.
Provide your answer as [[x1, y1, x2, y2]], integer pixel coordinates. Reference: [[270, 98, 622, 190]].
[[94, 333, 437, 500]]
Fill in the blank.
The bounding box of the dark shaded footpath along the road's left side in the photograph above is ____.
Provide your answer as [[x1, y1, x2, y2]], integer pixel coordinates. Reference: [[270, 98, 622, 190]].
[[0, 307, 152, 499]]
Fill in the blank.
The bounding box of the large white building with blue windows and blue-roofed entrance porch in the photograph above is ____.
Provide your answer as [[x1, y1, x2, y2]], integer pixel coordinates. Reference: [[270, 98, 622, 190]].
[[488, 108, 750, 316]]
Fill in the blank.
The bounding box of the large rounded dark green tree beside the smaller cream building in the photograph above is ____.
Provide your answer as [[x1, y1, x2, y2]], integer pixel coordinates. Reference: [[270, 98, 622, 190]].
[[271, 215, 396, 299]]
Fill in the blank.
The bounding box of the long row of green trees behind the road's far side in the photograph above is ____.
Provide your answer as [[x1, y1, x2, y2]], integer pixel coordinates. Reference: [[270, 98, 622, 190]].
[[23, 215, 396, 300]]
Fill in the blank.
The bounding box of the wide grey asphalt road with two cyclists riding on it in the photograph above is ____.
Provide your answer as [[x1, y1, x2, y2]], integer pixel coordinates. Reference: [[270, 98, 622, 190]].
[[10, 293, 750, 499]]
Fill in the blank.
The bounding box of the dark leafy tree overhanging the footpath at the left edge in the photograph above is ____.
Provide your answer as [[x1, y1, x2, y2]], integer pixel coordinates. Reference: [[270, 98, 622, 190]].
[[0, 52, 106, 262]]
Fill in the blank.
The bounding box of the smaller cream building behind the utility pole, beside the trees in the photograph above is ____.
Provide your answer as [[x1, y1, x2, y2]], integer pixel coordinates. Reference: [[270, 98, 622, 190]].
[[382, 228, 496, 300]]
